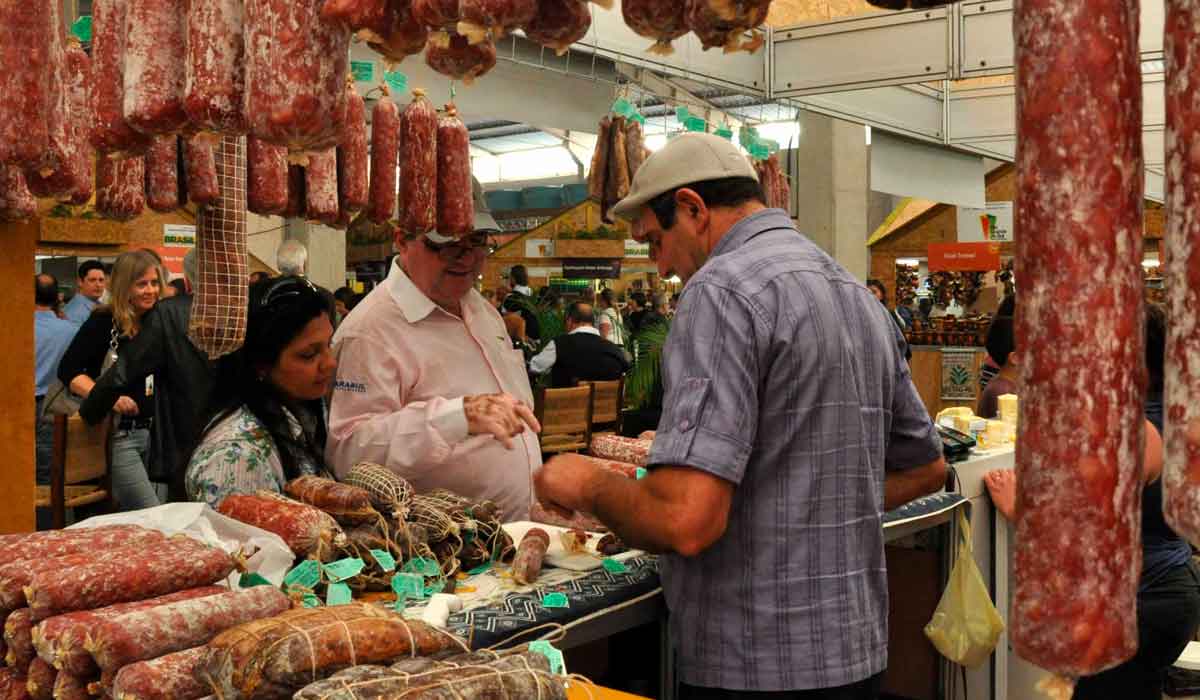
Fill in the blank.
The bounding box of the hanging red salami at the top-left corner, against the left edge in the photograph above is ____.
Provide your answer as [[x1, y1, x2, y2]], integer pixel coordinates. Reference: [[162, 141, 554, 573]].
[[0, 0, 58, 166]]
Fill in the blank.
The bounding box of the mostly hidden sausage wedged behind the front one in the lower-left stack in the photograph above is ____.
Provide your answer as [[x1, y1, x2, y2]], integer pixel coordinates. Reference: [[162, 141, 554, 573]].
[[34, 586, 228, 678]]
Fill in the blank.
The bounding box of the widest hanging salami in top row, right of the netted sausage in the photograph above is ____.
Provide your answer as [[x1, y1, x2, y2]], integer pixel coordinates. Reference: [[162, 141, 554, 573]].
[[245, 0, 350, 152]]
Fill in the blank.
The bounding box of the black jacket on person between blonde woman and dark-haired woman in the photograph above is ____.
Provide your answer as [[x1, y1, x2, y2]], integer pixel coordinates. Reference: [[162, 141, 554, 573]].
[[79, 295, 214, 497]]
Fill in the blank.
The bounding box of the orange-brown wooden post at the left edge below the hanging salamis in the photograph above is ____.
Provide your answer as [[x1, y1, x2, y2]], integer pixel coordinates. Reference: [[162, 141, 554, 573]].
[[0, 223, 37, 533]]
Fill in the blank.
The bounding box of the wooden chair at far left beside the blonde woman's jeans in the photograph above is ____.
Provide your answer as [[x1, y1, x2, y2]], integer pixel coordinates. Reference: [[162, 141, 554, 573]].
[[35, 415, 113, 528]]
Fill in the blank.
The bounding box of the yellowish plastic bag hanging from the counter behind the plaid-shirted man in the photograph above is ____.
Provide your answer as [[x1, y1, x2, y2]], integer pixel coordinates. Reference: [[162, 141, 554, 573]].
[[925, 508, 1004, 668]]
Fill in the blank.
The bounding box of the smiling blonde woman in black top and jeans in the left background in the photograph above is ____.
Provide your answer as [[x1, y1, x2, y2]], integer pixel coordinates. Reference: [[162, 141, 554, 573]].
[[59, 251, 166, 510]]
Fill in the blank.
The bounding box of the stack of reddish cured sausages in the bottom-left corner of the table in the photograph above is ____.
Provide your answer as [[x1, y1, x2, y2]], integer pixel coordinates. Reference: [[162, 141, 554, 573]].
[[0, 526, 297, 700]]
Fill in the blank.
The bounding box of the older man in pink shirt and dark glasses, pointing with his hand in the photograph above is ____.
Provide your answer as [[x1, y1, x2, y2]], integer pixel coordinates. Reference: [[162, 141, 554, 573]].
[[326, 183, 541, 520]]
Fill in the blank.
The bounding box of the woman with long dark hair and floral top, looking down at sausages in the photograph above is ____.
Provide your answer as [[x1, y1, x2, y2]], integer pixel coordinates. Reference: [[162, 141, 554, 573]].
[[185, 277, 337, 508]]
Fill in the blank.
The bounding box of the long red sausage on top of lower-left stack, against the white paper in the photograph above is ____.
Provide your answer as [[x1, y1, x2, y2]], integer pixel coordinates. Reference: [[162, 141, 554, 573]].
[[25, 536, 234, 621]]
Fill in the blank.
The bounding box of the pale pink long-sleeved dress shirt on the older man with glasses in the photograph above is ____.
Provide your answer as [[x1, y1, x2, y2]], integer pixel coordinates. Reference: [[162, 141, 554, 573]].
[[325, 263, 541, 521]]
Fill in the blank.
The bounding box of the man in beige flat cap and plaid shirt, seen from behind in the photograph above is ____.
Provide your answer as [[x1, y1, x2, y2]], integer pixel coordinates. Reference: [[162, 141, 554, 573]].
[[534, 133, 946, 700]]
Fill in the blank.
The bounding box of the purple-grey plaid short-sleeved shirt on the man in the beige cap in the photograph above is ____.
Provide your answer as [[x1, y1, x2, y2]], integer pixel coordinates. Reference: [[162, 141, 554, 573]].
[[650, 209, 941, 690]]
